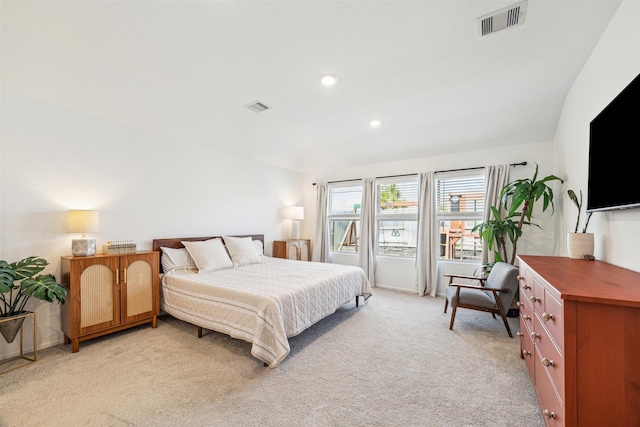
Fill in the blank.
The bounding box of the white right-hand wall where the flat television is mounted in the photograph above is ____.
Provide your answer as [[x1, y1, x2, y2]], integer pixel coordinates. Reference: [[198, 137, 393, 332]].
[[554, 0, 640, 271]]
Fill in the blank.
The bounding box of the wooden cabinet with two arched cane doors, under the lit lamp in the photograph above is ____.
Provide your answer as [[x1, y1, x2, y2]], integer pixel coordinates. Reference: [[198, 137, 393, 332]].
[[61, 251, 160, 353]]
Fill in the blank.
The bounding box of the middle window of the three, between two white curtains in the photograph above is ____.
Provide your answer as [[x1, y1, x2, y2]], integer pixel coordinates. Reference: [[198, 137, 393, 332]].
[[376, 177, 418, 258]]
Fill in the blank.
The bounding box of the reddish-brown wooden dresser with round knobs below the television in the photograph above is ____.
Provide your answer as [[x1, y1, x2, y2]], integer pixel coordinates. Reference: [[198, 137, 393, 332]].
[[518, 255, 640, 427]]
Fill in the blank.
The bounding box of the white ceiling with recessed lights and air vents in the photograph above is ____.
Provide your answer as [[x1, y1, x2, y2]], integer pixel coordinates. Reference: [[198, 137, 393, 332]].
[[1, 0, 620, 171]]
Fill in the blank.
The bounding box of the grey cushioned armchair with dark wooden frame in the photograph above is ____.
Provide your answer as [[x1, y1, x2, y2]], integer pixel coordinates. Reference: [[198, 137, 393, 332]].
[[444, 262, 519, 338]]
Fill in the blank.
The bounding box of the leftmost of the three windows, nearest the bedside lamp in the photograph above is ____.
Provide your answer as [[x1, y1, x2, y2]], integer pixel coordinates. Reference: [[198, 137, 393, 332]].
[[328, 183, 362, 253]]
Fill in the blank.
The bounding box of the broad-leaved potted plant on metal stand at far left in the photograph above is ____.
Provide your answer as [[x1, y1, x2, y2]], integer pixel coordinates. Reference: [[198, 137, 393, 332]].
[[0, 256, 67, 343]]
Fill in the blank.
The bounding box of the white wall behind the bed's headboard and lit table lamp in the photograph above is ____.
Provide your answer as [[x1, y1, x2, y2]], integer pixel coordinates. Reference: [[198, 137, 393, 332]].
[[0, 92, 302, 359]]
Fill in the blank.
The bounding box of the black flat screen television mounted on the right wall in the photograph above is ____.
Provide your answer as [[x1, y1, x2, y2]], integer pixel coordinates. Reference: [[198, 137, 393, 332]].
[[587, 74, 640, 212]]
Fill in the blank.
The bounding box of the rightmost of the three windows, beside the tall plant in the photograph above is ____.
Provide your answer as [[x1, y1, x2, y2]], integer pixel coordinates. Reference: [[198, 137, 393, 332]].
[[436, 170, 485, 260]]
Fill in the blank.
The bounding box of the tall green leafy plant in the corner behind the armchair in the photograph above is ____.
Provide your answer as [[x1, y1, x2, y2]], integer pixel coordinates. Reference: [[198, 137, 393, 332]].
[[473, 164, 564, 264]]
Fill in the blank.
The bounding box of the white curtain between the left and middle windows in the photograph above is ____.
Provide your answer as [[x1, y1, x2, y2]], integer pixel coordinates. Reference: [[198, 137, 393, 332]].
[[358, 178, 376, 286]]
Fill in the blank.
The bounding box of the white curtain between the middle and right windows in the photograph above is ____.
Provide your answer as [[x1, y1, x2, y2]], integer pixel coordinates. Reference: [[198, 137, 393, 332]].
[[416, 172, 439, 296]]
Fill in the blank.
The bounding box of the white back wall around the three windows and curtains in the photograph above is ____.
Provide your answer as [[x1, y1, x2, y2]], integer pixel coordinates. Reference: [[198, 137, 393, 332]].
[[302, 141, 562, 295]]
